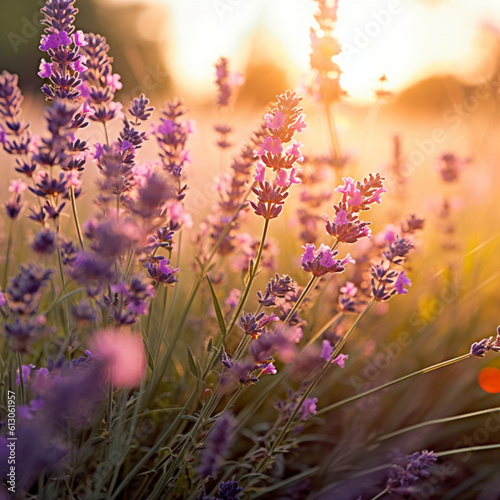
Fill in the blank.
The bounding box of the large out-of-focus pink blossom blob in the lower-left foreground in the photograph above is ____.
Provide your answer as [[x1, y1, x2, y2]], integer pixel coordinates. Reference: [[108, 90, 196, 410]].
[[91, 329, 146, 388]]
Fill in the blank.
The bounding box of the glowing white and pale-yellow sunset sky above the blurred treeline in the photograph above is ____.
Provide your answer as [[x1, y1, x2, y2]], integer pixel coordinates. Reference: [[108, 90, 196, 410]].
[[103, 0, 500, 97]]
